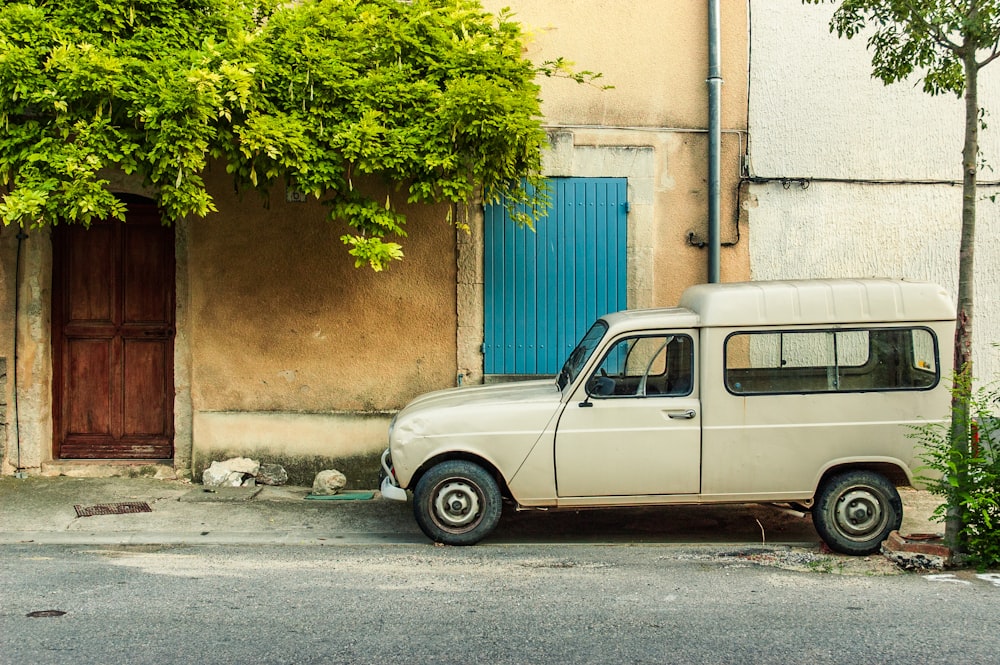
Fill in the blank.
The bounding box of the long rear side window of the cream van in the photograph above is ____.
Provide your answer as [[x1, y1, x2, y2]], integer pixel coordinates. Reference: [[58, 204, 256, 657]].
[[725, 328, 940, 395]]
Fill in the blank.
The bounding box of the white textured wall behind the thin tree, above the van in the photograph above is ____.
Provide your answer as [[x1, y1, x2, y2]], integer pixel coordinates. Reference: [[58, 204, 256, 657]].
[[744, 0, 1000, 381]]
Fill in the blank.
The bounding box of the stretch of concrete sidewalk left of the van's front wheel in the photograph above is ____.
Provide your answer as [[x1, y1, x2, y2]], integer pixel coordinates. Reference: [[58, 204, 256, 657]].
[[0, 477, 426, 545]]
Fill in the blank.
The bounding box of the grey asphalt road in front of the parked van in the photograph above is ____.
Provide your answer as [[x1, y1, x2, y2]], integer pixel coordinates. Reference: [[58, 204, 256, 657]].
[[0, 544, 1000, 665]]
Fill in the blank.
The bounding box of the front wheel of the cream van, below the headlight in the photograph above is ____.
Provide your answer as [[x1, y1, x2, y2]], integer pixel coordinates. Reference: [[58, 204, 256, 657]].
[[413, 460, 503, 545]]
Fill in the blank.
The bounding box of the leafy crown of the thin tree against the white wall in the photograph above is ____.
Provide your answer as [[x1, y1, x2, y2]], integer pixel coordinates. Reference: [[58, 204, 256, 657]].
[[803, 0, 1000, 96]]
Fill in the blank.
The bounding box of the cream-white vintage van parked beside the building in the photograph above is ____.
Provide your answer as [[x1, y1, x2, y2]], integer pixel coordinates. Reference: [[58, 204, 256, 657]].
[[381, 279, 955, 554]]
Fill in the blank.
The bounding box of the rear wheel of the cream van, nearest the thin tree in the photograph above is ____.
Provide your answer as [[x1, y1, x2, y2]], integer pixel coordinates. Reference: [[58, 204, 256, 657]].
[[812, 471, 903, 555]]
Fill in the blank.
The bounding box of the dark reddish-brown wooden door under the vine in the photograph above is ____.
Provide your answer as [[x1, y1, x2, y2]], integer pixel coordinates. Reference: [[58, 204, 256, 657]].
[[52, 203, 174, 460]]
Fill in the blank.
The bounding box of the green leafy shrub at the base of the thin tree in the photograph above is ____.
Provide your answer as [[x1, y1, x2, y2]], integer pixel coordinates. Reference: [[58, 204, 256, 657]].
[[914, 378, 1000, 569]]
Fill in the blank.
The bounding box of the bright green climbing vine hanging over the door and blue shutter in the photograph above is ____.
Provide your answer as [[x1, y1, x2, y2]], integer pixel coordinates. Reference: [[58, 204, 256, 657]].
[[0, 0, 556, 270]]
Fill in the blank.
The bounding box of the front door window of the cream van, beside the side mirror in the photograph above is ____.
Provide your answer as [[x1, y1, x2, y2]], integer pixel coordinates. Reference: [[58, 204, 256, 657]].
[[587, 335, 694, 398]]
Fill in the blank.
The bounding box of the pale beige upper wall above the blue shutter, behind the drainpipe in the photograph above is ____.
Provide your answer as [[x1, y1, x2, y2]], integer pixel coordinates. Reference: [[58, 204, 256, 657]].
[[494, 0, 747, 129]]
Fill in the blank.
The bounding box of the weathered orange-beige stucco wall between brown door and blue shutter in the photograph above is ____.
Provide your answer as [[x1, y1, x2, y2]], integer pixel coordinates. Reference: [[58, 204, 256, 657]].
[[186, 173, 457, 484]]
